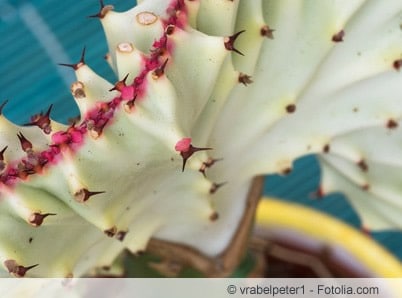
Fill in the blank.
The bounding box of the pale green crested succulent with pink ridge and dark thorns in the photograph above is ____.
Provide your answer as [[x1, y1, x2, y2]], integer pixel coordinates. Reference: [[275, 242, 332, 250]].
[[0, 0, 402, 277]]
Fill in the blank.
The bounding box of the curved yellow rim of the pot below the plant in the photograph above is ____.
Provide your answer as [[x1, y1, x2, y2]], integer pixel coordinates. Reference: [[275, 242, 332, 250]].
[[256, 198, 402, 278]]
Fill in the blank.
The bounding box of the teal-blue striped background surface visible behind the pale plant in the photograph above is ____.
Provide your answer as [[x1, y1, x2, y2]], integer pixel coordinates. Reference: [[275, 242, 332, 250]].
[[0, 0, 402, 259]]
